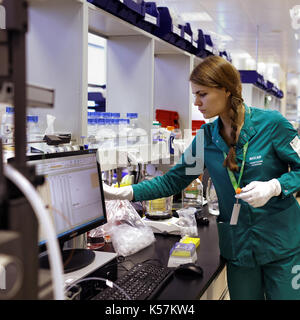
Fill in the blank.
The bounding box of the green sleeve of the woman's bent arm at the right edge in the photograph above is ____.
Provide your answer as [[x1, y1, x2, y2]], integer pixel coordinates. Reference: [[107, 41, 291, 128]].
[[272, 112, 300, 197]]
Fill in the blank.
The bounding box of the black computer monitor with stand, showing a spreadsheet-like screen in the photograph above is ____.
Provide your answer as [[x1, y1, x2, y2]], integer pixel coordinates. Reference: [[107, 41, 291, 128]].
[[27, 150, 107, 273]]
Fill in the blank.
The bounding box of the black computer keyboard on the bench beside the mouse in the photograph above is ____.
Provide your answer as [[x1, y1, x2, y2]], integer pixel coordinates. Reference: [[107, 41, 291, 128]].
[[92, 262, 174, 300]]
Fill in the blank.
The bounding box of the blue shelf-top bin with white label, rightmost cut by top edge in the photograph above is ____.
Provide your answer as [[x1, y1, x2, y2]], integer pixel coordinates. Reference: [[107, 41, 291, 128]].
[[136, 2, 160, 34]]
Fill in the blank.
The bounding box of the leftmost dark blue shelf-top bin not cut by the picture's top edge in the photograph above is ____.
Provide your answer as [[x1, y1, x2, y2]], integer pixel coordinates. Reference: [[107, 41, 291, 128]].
[[154, 7, 181, 45]]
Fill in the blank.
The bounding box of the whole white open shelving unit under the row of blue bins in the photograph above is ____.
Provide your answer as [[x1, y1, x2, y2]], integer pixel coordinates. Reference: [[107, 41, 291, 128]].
[[27, 0, 199, 142]]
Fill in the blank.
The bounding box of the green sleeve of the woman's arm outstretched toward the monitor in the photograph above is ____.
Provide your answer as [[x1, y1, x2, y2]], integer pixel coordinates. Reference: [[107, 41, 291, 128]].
[[132, 129, 204, 201]]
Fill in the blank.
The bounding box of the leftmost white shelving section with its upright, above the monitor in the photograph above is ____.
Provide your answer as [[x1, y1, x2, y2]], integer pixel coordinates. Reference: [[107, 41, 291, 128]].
[[26, 0, 88, 141]]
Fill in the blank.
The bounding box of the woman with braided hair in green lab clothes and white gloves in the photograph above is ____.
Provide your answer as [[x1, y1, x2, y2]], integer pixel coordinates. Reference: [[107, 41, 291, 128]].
[[104, 56, 300, 299]]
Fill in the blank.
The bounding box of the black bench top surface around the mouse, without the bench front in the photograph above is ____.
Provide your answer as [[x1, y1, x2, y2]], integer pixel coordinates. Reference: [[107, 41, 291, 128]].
[[97, 206, 225, 300]]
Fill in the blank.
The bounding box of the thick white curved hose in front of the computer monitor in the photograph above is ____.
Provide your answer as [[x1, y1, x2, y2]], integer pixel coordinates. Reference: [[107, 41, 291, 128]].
[[4, 164, 64, 300]]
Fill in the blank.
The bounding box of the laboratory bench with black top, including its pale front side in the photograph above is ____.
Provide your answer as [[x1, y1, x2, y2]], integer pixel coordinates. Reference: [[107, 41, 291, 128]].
[[94, 206, 228, 300]]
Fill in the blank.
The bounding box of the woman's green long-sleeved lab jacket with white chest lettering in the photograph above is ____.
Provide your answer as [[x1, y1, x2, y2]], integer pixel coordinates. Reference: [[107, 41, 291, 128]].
[[133, 105, 300, 267]]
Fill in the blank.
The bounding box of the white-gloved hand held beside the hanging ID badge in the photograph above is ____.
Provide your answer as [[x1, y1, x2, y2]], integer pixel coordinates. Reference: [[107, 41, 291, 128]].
[[235, 179, 281, 208]]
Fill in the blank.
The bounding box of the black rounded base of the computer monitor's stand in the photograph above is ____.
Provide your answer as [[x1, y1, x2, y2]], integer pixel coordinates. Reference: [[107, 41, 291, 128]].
[[39, 249, 95, 273]]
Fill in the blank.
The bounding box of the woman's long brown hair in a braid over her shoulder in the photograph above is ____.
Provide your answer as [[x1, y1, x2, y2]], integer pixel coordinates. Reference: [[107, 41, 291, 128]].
[[190, 56, 243, 171]]
